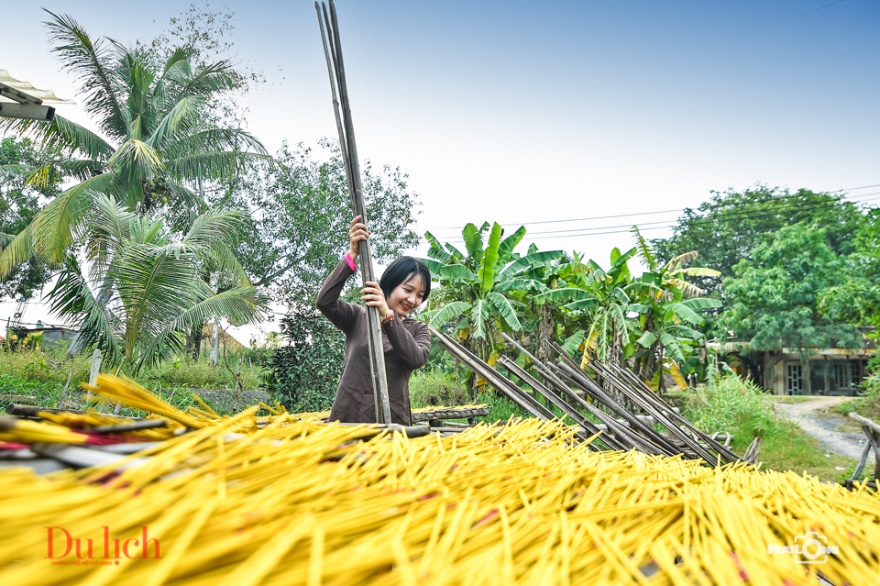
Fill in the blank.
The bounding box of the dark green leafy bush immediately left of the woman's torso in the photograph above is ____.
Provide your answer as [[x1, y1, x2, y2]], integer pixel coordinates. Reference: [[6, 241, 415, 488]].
[[263, 310, 345, 412]]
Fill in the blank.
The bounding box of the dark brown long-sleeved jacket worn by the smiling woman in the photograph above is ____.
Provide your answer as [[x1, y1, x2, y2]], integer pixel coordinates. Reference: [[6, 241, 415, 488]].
[[317, 258, 431, 425]]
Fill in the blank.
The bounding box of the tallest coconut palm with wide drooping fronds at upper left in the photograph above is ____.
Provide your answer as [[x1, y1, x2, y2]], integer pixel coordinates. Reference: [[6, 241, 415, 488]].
[[0, 11, 266, 279]]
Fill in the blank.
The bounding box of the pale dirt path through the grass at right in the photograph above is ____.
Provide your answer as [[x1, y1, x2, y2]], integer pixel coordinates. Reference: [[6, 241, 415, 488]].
[[775, 397, 865, 460]]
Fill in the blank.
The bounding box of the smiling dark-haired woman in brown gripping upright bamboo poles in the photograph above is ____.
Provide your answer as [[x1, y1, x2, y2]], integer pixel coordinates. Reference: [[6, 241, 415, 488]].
[[317, 217, 431, 425]]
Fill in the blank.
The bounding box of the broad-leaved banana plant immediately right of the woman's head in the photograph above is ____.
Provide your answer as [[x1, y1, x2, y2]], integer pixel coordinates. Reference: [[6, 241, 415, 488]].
[[425, 222, 561, 360]]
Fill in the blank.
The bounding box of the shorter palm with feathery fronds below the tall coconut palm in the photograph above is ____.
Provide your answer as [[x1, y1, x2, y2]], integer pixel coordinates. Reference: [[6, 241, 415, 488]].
[[50, 196, 262, 371]]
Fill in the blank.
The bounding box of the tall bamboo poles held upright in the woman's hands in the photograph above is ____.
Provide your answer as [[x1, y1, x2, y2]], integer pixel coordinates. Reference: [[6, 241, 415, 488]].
[[315, 0, 391, 423]]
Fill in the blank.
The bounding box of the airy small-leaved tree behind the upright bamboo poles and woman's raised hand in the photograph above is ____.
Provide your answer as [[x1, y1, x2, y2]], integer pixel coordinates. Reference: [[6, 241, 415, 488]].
[[212, 140, 418, 305]]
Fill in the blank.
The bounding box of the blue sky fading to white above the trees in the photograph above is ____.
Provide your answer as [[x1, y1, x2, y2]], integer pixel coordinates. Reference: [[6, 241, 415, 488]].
[[0, 0, 880, 328]]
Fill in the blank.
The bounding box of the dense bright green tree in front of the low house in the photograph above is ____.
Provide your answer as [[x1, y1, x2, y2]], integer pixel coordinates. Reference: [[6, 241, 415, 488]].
[[719, 223, 862, 374]]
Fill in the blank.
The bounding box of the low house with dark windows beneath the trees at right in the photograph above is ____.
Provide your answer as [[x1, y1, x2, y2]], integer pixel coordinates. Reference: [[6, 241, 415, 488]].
[[716, 342, 877, 395]]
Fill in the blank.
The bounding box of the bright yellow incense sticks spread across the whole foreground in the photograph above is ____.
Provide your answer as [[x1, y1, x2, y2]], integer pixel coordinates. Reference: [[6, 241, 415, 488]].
[[0, 377, 880, 586]]
